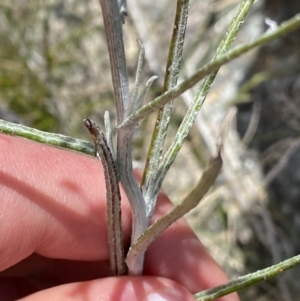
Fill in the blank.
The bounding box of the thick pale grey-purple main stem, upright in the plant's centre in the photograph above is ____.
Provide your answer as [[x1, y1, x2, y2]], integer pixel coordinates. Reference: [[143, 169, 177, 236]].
[[100, 0, 148, 275]]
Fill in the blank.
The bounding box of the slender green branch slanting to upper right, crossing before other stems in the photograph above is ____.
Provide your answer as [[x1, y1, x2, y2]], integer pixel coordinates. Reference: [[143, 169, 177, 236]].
[[119, 14, 300, 128]]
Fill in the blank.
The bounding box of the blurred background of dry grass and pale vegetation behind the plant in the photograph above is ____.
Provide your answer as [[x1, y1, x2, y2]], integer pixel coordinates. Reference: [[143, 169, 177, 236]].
[[0, 0, 300, 300]]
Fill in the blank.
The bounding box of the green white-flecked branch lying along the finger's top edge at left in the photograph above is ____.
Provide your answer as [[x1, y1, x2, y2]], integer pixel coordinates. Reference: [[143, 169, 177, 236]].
[[0, 119, 95, 156]]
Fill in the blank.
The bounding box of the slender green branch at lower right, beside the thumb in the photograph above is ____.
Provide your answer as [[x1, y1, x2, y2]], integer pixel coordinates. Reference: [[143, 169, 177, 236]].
[[195, 255, 300, 301]]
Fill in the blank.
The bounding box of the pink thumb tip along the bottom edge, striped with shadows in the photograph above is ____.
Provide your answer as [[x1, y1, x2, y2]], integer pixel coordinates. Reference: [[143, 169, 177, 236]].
[[20, 276, 195, 301]]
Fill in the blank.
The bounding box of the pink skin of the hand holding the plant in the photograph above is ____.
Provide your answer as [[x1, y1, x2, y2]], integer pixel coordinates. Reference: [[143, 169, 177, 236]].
[[0, 134, 238, 301]]
